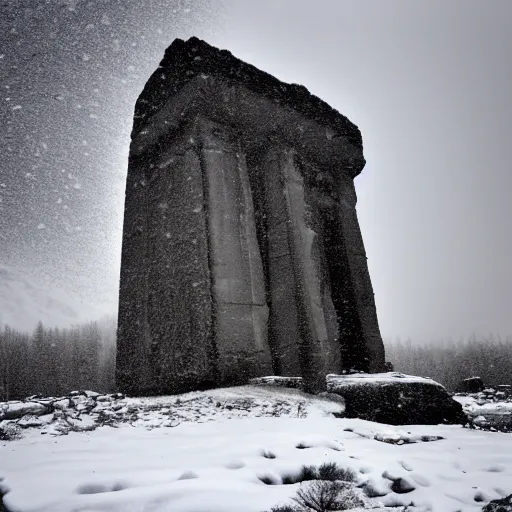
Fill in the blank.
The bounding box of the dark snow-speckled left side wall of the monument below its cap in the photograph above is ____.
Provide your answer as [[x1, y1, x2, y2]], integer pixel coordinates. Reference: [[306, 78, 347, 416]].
[[117, 123, 218, 394]]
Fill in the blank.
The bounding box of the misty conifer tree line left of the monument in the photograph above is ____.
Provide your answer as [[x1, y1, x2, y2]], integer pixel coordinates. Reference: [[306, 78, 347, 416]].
[[0, 317, 116, 400]]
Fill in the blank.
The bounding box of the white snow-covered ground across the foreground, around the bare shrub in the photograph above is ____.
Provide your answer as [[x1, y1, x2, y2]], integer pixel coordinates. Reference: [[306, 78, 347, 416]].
[[0, 386, 512, 512]]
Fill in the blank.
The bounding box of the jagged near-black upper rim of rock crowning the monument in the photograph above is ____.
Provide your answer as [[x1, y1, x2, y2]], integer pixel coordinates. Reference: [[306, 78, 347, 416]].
[[133, 37, 362, 146]]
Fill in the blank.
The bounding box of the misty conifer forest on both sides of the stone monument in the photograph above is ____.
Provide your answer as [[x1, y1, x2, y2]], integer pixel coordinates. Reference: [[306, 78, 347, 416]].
[[0, 317, 512, 400]]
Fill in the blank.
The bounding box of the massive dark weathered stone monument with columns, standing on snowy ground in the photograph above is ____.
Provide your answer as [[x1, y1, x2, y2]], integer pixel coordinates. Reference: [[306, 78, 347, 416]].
[[116, 38, 385, 395]]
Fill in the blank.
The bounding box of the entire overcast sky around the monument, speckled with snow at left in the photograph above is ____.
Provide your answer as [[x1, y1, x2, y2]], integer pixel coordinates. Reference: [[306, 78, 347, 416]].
[[0, 0, 512, 341]]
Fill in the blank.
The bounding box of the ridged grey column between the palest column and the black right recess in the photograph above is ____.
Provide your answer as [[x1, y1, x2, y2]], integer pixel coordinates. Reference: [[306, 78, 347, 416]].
[[262, 148, 332, 391]]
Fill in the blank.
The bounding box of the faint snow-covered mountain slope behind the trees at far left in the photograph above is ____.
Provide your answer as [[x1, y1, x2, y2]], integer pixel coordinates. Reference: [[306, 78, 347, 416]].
[[0, 265, 102, 332]]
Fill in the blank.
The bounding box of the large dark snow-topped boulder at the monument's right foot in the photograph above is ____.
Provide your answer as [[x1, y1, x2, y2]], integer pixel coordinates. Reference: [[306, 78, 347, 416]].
[[327, 372, 467, 425]]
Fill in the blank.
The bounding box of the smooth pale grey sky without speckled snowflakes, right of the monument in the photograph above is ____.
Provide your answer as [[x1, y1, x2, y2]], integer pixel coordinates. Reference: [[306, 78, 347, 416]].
[[214, 0, 512, 340]]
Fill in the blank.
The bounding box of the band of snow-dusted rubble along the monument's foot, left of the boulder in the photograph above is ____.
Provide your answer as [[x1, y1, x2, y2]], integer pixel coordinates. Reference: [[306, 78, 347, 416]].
[[0, 386, 344, 440]]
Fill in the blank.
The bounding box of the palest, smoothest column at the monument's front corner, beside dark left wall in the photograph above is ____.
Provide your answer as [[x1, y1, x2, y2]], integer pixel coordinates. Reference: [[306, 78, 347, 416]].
[[199, 118, 272, 383]]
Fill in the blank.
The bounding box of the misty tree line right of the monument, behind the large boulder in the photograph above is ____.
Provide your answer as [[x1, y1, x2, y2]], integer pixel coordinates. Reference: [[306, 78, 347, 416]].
[[386, 335, 512, 391]]
